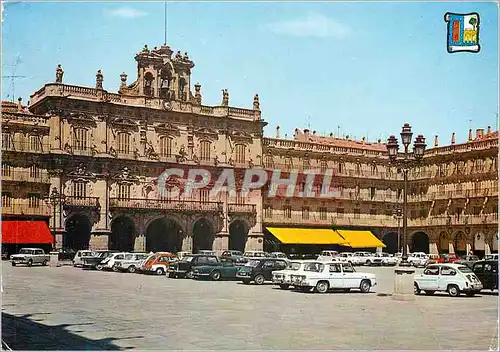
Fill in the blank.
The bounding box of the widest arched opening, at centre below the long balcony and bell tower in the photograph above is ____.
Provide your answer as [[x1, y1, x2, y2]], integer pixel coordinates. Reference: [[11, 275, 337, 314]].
[[146, 218, 183, 253]]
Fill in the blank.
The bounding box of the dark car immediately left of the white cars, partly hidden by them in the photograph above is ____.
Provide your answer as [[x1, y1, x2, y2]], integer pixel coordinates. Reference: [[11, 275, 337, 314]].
[[236, 258, 288, 285]]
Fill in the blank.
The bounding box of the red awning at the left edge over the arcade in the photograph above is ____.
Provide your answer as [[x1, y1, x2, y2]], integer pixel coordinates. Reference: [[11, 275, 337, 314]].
[[2, 220, 54, 244]]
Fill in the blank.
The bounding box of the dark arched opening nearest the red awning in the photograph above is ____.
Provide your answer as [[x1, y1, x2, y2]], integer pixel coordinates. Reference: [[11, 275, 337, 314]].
[[63, 213, 92, 251]]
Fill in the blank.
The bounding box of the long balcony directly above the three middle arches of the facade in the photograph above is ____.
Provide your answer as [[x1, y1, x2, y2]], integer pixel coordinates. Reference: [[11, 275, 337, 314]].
[[109, 198, 224, 213]]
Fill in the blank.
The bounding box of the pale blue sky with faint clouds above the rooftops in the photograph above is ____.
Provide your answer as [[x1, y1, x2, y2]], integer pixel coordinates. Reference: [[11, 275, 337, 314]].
[[2, 2, 499, 145]]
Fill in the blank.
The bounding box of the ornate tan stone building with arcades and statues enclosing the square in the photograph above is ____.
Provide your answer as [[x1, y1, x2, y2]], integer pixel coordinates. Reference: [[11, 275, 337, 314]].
[[2, 45, 498, 252]]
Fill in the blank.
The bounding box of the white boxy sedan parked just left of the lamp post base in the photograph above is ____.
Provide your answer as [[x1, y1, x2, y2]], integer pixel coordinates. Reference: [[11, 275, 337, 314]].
[[291, 262, 377, 293]]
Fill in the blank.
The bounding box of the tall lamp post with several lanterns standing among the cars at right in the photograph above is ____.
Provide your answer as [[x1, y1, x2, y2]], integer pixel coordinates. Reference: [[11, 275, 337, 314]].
[[387, 123, 426, 266]]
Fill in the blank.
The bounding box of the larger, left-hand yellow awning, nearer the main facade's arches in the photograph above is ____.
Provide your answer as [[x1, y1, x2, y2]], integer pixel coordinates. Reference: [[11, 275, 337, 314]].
[[267, 227, 348, 245]]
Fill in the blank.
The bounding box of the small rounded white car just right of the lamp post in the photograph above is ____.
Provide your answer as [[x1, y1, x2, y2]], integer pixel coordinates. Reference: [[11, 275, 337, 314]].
[[413, 264, 483, 297]]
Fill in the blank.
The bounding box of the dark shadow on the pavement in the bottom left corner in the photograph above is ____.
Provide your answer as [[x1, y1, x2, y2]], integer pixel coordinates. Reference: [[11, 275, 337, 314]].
[[2, 313, 142, 351]]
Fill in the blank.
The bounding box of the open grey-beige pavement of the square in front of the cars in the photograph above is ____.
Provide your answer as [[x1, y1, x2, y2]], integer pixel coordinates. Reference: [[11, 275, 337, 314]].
[[2, 262, 498, 350]]
